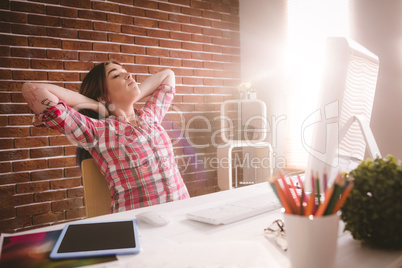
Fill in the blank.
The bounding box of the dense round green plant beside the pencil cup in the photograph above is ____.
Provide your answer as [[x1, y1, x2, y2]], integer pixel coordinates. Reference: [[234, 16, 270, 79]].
[[341, 156, 402, 248]]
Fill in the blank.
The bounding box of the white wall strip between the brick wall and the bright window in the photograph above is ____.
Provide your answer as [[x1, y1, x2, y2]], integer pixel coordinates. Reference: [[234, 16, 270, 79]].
[[240, 0, 288, 169]]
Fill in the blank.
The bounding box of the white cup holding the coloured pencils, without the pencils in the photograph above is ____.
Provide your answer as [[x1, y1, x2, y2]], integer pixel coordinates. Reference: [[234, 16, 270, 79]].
[[284, 213, 340, 268]]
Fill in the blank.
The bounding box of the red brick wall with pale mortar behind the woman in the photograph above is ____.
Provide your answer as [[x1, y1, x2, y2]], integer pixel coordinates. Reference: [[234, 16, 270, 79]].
[[0, 0, 239, 232]]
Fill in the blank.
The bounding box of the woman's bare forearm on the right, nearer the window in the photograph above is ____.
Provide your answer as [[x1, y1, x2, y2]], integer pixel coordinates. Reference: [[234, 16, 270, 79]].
[[139, 69, 175, 99]]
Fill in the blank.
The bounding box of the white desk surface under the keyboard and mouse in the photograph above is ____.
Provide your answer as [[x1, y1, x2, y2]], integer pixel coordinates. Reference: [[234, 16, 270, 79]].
[[7, 183, 402, 268]]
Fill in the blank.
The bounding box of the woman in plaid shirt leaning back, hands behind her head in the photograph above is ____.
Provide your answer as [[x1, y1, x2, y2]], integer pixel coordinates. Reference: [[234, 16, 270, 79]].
[[22, 62, 189, 212]]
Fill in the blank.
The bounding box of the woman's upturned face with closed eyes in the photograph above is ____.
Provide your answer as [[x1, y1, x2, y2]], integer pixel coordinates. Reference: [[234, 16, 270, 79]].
[[105, 63, 140, 105]]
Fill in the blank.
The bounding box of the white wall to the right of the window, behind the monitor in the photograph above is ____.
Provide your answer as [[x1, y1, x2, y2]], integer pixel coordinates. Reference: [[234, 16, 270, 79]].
[[351, 0, 402, 159]]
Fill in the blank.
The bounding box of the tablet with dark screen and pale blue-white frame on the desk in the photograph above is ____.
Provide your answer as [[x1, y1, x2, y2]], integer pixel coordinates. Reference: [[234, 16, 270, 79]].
[[50, 219, 140, 260]]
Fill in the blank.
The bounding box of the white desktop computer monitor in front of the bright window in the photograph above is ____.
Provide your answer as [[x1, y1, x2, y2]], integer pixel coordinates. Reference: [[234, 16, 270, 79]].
[[302, 37, 381, 191]]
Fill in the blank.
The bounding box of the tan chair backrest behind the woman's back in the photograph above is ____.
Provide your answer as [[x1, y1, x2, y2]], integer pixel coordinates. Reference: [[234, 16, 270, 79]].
[[81, 158, 112, 218]]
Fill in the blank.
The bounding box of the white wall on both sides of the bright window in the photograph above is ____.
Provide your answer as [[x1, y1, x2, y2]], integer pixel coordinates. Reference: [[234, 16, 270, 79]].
[[240, 0, 402, 165]]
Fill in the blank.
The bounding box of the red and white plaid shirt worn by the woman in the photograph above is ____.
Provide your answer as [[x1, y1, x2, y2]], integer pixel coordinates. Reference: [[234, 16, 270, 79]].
[[40, 85, 189, 212]]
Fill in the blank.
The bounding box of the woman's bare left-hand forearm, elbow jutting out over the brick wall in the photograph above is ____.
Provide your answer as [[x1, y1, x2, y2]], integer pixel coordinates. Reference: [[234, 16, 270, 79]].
[[22, 83, 107, 115]]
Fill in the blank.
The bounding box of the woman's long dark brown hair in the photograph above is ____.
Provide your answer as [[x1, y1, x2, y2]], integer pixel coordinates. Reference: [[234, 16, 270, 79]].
[[76, 61, 121, 166]]
